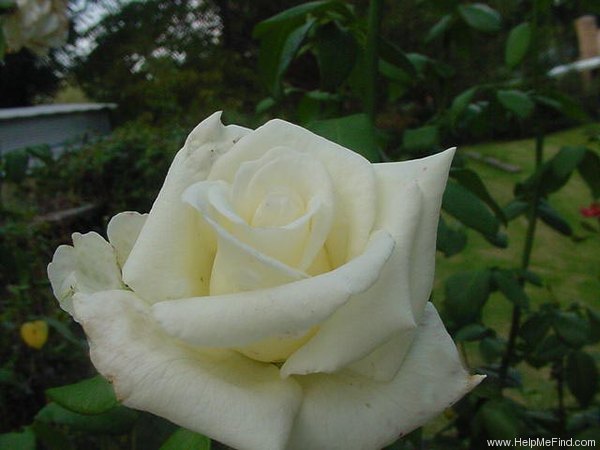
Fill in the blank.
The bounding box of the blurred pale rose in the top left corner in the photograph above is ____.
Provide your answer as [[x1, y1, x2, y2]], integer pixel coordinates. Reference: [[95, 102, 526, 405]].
[[3, 0, 69, 55]]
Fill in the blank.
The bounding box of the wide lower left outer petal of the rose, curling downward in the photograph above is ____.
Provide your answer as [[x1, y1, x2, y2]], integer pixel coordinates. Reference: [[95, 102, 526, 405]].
[[74, 291, 302, 450]]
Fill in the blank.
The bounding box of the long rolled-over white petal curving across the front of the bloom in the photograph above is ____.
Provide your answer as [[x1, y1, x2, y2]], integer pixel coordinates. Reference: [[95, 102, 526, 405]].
[[153, 231, 394, 347]]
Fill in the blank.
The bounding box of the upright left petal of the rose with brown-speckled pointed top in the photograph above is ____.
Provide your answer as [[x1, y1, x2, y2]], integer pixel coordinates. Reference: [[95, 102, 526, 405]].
[[123, 113, 250, 303]]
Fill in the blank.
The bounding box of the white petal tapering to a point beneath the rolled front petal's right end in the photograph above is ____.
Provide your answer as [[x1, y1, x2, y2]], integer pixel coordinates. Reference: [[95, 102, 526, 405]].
[[281, 182, 422, 376]]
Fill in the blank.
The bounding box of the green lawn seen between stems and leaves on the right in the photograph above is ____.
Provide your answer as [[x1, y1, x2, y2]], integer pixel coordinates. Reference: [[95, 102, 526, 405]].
[[433, 127, 600, 414]]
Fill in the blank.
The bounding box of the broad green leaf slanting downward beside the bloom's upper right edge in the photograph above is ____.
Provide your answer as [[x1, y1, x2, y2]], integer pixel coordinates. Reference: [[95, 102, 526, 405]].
[[442, 181, 500, 236]]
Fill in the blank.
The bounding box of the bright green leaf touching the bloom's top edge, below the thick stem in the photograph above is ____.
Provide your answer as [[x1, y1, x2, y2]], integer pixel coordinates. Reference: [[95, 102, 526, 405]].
[[307, 114, 379, 162]]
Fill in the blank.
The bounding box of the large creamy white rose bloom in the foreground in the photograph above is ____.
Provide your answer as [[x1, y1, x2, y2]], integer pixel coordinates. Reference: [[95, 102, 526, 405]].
[[48, 113, 482, 450]]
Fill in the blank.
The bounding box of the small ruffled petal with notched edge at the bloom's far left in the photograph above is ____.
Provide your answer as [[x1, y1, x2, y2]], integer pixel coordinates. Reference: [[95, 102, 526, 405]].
[[48, 232, 123, 315]]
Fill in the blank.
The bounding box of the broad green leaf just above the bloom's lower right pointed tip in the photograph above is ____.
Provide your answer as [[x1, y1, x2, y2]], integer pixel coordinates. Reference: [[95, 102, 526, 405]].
[[445, 270, 491, 325]]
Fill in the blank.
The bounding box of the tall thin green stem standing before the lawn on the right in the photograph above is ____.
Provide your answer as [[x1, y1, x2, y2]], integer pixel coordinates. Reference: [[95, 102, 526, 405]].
[[499, 130, 544, 383]]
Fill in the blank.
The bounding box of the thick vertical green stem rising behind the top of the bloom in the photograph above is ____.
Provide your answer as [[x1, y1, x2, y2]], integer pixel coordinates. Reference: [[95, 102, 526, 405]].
[[364, 0, 383, 123]]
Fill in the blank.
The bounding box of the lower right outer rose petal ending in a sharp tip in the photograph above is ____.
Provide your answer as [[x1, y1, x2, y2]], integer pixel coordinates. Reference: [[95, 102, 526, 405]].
[[289, 304, 484, 450]]
